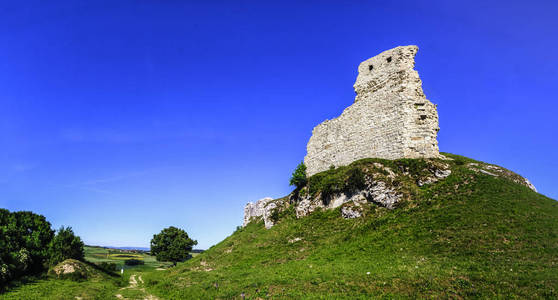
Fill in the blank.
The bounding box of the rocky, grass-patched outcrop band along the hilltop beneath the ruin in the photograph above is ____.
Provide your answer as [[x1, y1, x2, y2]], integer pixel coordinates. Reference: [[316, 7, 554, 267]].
[[243, 155, 537, 229]]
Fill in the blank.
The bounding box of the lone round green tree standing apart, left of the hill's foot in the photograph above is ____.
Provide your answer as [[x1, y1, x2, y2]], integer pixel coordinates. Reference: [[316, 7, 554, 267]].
[[151, 226, 198, 265]]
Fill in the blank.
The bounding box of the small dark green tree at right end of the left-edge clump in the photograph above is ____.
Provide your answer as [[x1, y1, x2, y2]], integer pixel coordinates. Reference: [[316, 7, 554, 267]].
[[49, 226, 85, 265]]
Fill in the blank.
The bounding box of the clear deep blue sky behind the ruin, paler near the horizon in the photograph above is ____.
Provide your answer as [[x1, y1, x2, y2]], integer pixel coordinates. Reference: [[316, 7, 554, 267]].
[[0, 0, 558, 248]]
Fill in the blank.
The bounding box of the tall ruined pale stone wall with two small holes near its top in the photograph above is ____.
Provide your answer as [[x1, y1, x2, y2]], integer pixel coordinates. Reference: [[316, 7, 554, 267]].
[[304, 46, 440, 176]]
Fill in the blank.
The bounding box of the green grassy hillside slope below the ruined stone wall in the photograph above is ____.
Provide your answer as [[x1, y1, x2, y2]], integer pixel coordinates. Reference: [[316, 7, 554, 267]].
[[144, 154, 558, 299]]
